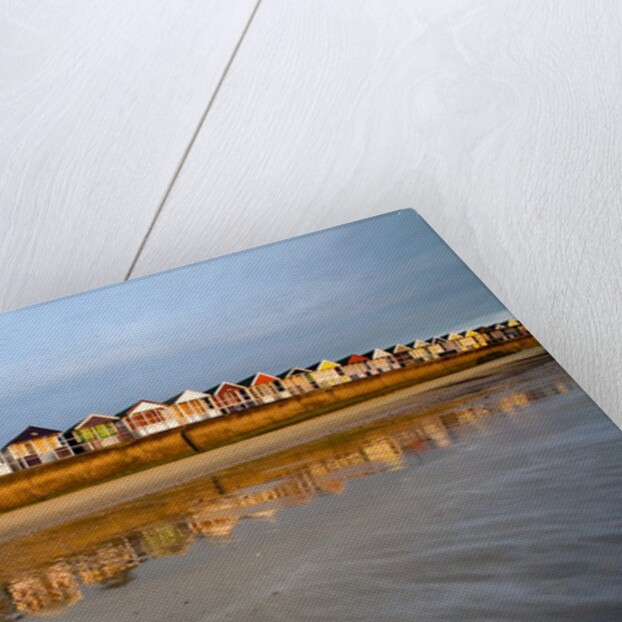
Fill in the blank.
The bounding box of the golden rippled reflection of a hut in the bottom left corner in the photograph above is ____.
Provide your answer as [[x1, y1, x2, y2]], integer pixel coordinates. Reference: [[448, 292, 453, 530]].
[[8, 562, 82, 617]]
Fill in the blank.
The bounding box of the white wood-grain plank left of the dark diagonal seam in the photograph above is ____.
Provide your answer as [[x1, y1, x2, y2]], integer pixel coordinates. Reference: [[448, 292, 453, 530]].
[[0, 0, 255, 309]]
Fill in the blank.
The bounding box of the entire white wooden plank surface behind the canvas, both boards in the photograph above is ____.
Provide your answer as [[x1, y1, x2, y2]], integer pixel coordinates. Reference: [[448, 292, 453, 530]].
[[0, 0, 622, 425]]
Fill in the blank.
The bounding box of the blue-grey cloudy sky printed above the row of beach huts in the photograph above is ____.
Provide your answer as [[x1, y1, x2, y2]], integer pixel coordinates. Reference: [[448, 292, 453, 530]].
[[0, 210, 511, 445]]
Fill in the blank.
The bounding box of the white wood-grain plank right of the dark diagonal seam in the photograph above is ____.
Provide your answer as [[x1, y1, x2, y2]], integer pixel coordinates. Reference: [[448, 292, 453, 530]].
[[135, 0, 622, 425]]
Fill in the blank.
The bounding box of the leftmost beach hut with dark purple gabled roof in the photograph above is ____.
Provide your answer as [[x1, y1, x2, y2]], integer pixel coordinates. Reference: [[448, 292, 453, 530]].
[[2, 426, 73, 470]]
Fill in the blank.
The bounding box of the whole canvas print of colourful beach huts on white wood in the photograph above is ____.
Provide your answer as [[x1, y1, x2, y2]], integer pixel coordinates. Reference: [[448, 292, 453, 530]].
[[0, 210, 622, 622]]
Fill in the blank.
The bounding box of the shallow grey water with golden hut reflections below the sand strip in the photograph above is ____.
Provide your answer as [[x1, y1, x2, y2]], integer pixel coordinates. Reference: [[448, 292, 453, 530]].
[[0, 358, 622, 622]]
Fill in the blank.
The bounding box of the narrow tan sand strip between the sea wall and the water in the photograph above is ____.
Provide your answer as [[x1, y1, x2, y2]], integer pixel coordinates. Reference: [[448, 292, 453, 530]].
[[0, 348, 548, 541]]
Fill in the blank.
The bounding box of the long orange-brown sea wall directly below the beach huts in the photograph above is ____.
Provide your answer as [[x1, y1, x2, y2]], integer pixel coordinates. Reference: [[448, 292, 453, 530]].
[[0, 337, 539, 512]]
